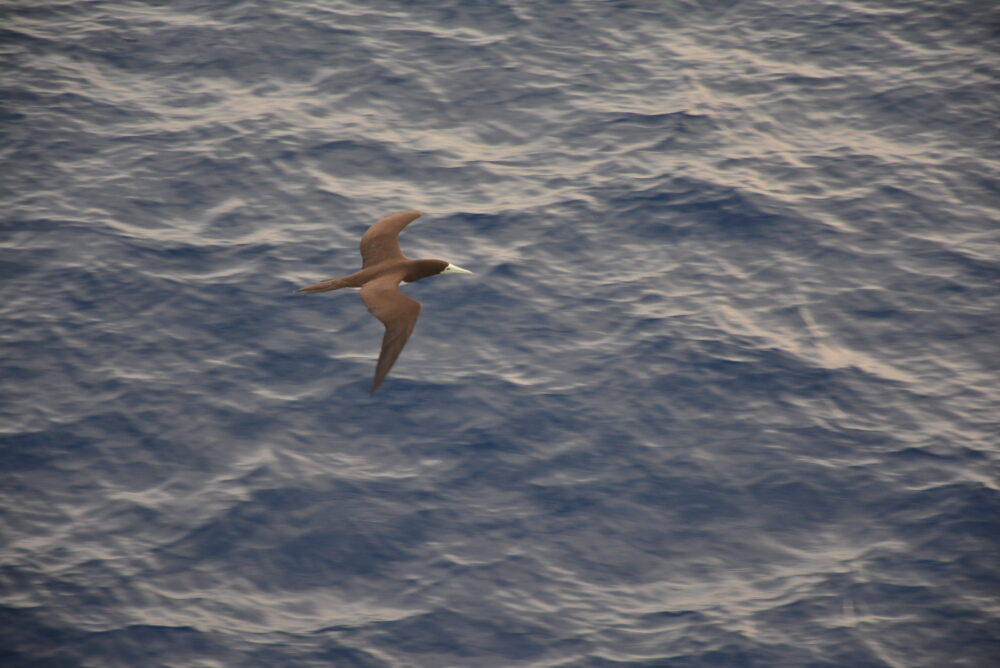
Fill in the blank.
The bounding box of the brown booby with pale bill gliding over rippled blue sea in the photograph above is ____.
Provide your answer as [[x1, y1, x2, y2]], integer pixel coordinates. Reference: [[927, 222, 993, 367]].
[[298, 211, 472, 394]]
